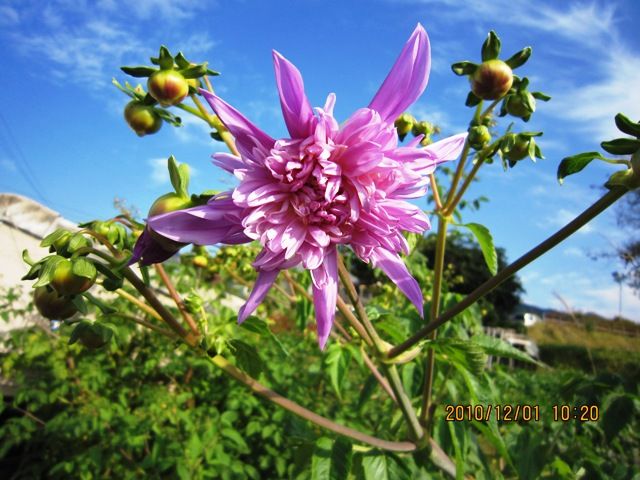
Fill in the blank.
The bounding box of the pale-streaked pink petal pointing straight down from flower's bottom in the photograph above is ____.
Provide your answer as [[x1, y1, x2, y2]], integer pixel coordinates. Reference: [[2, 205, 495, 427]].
[[311, 247, 338, 350]]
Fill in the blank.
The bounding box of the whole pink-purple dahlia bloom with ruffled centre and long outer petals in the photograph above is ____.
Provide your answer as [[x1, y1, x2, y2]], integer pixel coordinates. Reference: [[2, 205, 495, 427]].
[[140, 25, 466, 348]]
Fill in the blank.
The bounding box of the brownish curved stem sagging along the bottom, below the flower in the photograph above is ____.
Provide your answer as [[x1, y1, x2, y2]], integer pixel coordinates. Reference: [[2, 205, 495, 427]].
[[210, 355, 417, 452]]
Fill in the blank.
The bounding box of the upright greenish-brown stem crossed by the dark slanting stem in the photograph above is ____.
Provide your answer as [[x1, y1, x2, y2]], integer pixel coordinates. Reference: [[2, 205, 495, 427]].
[[420, 216, 449, 425]]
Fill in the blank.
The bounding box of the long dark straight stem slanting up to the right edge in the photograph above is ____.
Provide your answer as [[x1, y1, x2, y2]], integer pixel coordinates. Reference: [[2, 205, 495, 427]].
[[387, 185, 628, 358]]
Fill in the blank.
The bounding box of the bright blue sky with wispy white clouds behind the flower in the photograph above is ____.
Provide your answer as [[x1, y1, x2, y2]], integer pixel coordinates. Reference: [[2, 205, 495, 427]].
[[0, 0, 640, 321]]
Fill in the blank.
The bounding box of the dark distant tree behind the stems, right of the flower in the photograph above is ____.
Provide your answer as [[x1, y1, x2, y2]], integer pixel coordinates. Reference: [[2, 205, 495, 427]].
[[418, 232, 524, 325]]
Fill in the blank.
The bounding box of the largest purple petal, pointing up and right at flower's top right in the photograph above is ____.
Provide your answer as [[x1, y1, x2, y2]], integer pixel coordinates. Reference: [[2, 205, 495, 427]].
[[369, 24, 431, 122]]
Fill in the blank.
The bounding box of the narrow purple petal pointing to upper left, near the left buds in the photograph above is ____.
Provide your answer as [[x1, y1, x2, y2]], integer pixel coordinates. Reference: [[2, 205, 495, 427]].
[[200, 89, 275, 161]]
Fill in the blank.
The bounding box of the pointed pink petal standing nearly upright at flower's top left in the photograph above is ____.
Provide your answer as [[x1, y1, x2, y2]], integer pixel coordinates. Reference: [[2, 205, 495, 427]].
[[273, 50, 314, 138]]
